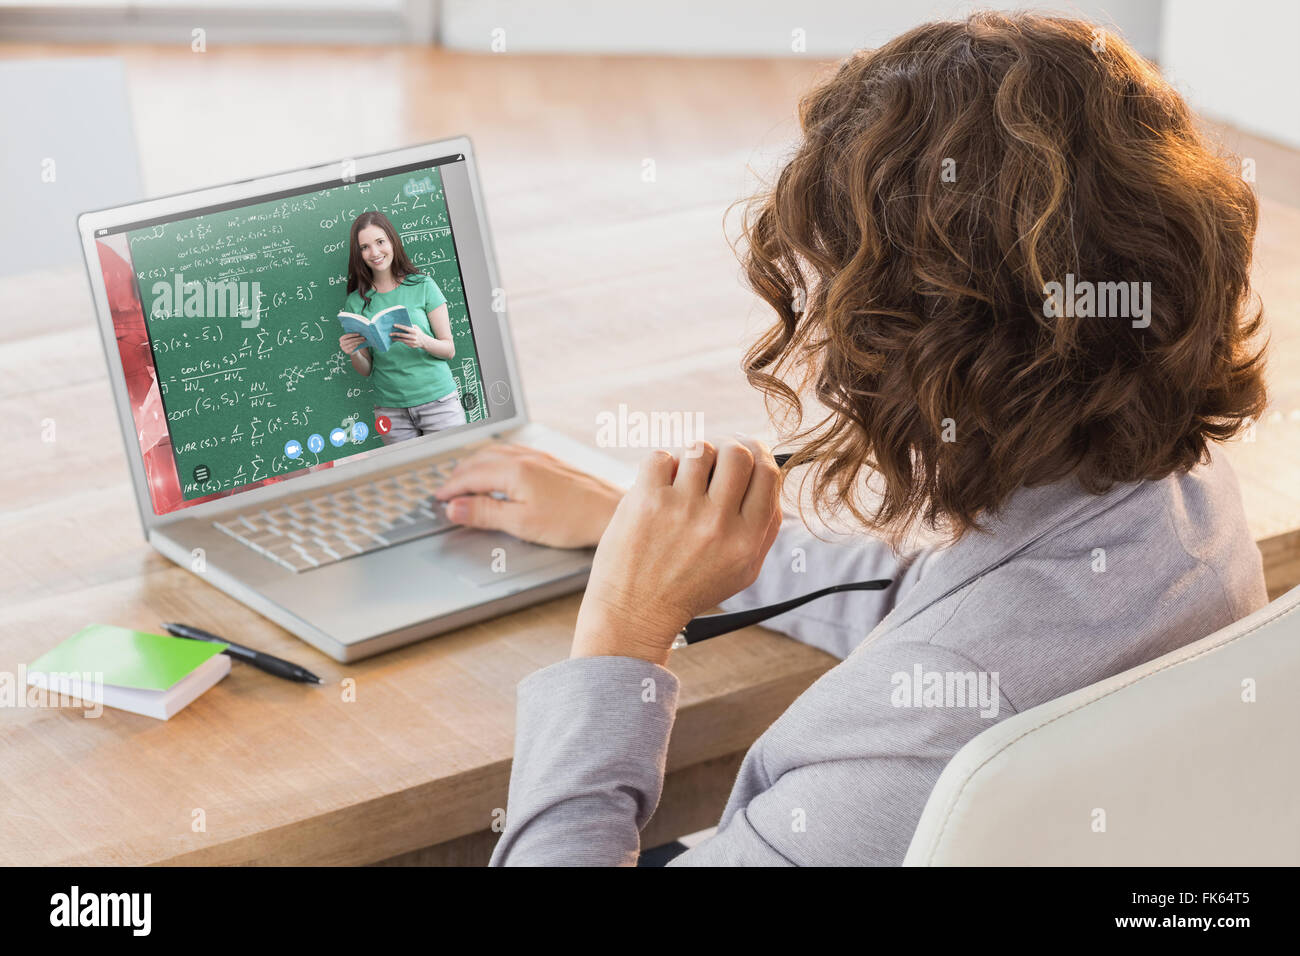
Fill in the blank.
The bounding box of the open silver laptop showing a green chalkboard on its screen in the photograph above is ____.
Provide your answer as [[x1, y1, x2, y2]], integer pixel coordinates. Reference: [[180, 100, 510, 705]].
[[78, 137, 633, 662]]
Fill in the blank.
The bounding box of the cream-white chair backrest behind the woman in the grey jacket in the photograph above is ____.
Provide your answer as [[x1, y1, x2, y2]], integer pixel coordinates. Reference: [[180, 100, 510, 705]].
[[904, 588, 1300, 866]]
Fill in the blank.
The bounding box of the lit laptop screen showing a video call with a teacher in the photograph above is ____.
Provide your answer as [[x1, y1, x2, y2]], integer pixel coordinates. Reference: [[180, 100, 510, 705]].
[[87, 155, 495, 515]]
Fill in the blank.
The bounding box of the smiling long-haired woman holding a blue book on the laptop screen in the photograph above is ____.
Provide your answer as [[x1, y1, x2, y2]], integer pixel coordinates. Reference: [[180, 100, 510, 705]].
[[338, 212, 465, 445]]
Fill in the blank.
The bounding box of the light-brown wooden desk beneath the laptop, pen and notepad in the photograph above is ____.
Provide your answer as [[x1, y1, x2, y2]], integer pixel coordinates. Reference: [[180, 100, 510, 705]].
[[0, 47, 1300, 864]]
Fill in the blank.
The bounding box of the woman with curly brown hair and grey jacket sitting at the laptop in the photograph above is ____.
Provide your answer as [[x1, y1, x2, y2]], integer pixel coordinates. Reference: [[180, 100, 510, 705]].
[[441, 13, 1266, 865]]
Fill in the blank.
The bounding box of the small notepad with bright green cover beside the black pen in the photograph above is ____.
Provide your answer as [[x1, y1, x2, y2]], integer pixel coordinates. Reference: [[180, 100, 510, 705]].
[[27, 624, 230, 721]]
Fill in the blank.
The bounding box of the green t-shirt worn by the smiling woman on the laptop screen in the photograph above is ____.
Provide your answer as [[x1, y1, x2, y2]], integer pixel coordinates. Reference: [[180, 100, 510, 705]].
[[343, 274, 456, 408]]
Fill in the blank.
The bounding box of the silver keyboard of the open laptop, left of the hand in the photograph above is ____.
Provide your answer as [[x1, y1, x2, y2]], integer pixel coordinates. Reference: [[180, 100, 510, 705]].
[[213, 458, 459, 571]]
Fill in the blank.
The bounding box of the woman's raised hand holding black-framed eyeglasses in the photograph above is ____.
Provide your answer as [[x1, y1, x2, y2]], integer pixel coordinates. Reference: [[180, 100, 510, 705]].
[[571, 438, 781, 665]]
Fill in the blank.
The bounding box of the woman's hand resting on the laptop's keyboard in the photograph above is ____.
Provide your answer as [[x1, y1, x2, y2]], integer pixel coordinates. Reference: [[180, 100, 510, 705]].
[[434, 442, 623, 548]]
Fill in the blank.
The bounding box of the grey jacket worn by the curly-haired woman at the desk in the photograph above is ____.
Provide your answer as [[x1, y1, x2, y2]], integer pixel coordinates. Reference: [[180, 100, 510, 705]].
[[491, 454, 1266, 865]]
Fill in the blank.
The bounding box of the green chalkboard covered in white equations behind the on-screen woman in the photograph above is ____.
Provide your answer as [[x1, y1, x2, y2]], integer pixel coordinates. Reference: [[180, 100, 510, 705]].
[[127, 166, 485, 499]]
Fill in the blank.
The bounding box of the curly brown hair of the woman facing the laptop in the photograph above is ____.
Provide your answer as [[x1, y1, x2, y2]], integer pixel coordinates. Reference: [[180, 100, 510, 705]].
[[742, 13, 1266, 537]]
